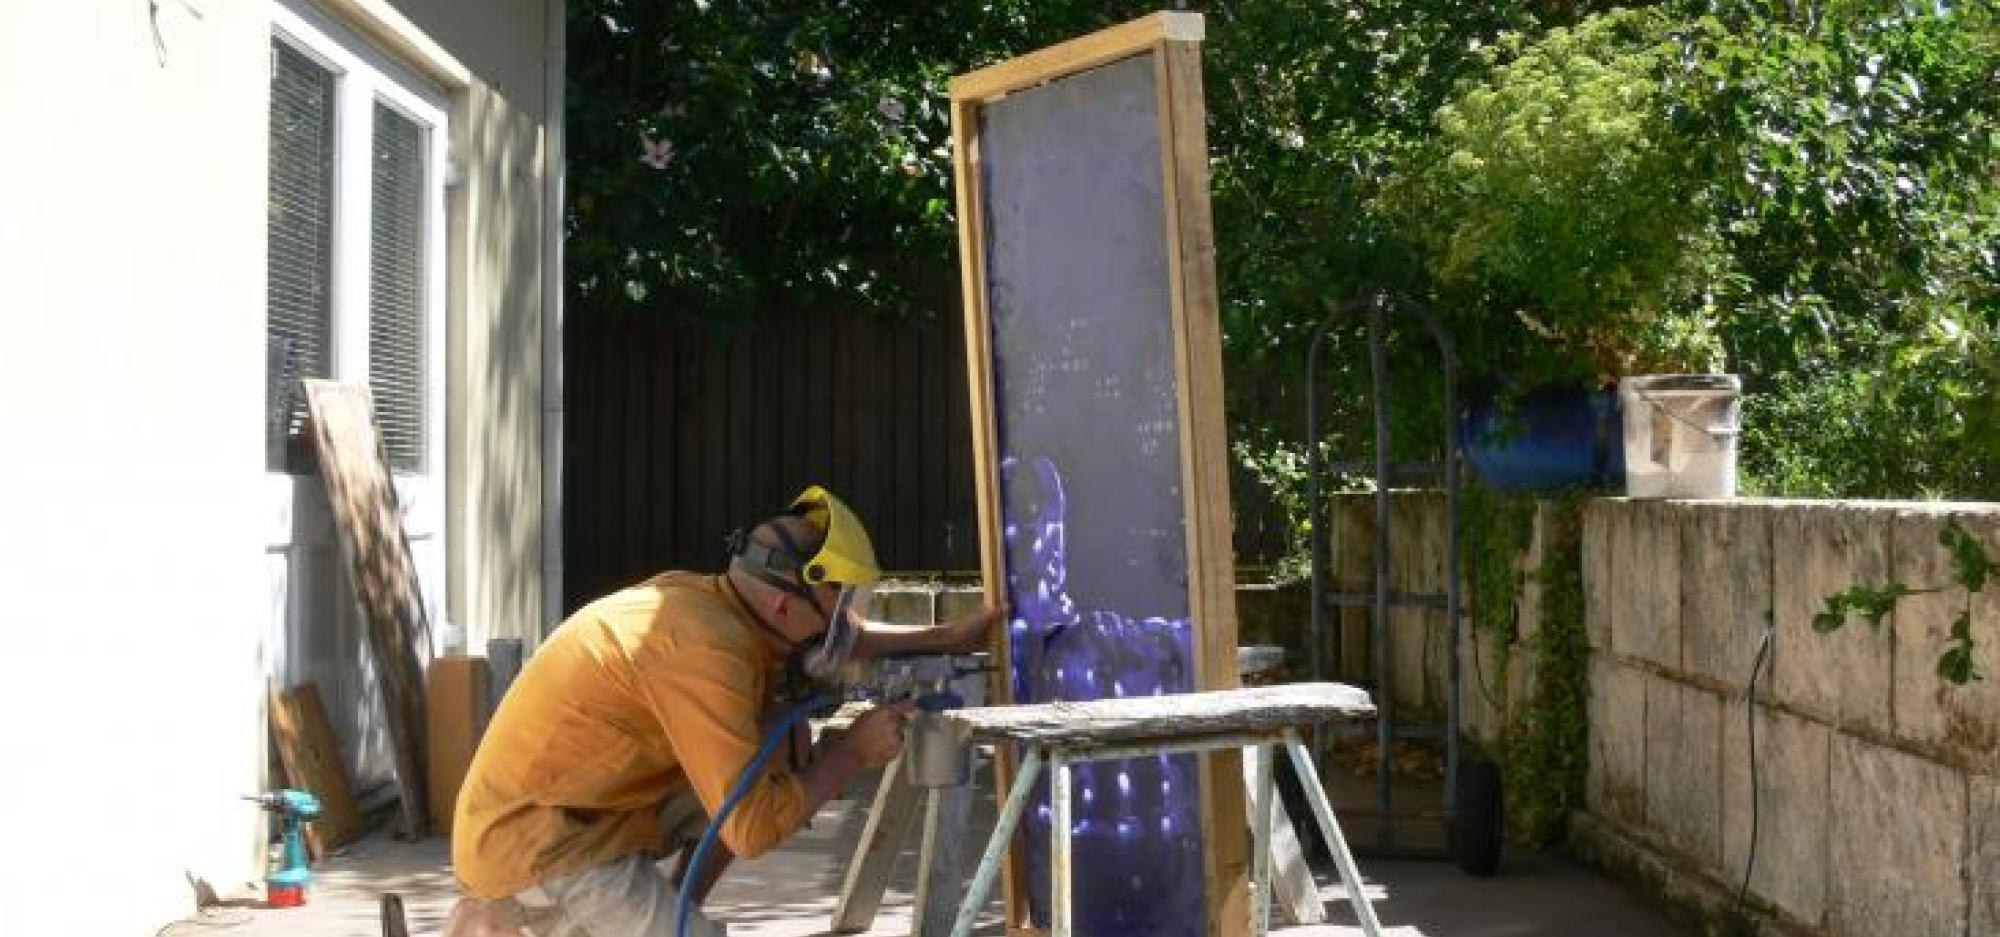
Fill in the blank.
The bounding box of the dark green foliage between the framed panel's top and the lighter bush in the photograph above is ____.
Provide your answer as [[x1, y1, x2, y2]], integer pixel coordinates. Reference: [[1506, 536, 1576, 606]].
[[1206, 0, 1576, 362]]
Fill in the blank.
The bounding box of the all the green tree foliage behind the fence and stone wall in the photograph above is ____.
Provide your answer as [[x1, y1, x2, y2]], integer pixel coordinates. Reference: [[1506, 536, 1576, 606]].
[[566, 0, 2000, 504]]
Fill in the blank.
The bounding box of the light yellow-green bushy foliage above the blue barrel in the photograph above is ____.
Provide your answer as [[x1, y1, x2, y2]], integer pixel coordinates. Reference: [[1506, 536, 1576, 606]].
[[1376, 10, 1716, 374]]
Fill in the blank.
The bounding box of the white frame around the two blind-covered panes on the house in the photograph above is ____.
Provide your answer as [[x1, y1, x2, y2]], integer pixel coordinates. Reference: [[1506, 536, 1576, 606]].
[[266, 0, 452, 639]]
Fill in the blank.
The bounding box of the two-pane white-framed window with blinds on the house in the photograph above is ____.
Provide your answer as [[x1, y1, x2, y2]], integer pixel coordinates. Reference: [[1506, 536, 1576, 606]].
[[264, 15, 448, 475]]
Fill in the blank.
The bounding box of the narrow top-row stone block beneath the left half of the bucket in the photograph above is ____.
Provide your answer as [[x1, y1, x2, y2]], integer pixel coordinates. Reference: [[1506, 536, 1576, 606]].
[[1612, 501, 1680, 671]]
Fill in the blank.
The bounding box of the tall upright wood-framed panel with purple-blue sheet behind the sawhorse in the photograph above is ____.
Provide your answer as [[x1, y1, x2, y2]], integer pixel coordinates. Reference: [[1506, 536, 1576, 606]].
[[952, 12, 1248, 937]]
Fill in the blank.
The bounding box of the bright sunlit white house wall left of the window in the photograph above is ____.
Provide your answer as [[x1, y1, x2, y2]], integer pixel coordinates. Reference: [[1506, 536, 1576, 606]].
[[0, 0, 270, 935]]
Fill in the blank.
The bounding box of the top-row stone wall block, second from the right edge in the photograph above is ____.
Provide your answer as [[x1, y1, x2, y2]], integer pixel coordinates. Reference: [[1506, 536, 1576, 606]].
[[1772, 503, 1894, 733]]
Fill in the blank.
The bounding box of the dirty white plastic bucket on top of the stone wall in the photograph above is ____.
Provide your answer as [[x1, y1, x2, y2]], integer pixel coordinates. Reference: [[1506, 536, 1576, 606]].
[[1618, 374, 1742, 499]]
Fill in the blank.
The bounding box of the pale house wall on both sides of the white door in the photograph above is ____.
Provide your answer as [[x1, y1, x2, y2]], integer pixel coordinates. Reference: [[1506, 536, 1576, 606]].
[[0, 0, 556, 935]]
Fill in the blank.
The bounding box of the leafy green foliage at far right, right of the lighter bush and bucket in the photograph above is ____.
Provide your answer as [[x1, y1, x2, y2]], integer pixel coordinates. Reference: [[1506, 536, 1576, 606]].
[[1680, 2, 2000, 497]]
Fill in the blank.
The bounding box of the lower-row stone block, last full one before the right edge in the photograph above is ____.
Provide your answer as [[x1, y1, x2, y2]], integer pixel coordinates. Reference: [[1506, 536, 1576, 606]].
[[1826, 735, 1968, 937]]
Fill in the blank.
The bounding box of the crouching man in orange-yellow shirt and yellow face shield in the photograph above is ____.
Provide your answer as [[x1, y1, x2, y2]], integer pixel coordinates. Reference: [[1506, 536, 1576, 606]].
[[446, 487, 1000, 937]]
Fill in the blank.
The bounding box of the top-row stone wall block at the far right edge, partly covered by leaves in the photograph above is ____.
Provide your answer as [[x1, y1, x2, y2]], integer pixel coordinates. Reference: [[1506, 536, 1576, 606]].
[[1892, 509, 2000, 763]]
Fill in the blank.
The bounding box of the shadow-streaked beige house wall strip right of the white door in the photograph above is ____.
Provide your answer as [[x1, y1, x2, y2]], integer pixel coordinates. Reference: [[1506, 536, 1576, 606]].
[[410, 0, 560, 651]]
